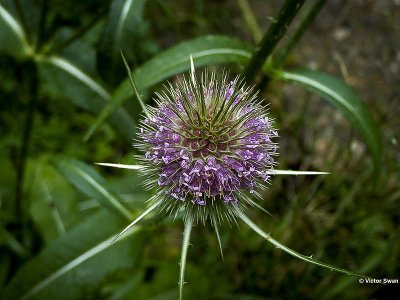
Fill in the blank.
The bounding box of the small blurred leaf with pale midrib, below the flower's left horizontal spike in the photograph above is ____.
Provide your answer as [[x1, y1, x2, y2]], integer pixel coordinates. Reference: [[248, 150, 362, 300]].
[[54, 159, 132, 220]]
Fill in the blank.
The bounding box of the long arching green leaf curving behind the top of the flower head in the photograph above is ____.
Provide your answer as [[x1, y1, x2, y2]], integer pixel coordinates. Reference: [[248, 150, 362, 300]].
[[85, 35, 251, 140]]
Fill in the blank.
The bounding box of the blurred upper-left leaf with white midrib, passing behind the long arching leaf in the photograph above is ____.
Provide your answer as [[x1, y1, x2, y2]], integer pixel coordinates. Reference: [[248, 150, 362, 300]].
[[37, 56, 136, 142]]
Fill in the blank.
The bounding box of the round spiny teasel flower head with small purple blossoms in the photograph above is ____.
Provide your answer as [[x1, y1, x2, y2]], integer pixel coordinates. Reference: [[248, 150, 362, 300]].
[[137, 72, 278, 222]]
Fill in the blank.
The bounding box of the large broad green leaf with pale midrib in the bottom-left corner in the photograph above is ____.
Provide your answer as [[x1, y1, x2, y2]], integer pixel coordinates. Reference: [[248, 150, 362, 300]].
[[2, 210, 140, 299]]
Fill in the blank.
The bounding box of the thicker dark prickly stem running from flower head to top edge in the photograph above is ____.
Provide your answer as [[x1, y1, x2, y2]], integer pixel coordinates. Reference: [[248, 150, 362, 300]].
[[244, 0, 305, 81]]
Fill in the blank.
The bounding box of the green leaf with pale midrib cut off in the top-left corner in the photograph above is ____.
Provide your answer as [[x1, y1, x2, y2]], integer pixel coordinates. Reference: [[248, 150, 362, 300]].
[[0, 4, 33, 57]]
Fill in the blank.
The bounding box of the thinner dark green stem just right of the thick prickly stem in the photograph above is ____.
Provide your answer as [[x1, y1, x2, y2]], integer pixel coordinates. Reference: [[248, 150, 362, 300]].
[[274, 0, 327, 67]]
